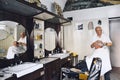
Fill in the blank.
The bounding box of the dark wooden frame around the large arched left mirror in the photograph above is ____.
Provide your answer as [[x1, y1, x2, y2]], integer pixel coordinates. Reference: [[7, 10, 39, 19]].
[[0, 10, 34, 68]]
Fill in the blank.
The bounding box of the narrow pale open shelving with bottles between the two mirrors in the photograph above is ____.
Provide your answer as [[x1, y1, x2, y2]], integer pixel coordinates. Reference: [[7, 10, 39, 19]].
[[34, 19, 45, 58]]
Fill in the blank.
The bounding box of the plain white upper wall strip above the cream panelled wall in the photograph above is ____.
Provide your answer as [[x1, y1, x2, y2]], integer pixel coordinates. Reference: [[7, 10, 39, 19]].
[[64, 5, 120, 21]]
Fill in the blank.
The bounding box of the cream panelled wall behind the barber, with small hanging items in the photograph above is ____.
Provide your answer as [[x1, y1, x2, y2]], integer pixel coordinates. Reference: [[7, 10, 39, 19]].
[[64, 18, 109, 59]]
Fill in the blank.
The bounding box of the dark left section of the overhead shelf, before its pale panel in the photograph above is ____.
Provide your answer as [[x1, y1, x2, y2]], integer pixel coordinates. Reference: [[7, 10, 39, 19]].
[[0, 0, 42, 16]]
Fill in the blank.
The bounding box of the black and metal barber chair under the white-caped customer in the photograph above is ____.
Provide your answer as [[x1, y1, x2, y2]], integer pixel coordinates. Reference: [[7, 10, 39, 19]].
[[60, 58, 102, 80]]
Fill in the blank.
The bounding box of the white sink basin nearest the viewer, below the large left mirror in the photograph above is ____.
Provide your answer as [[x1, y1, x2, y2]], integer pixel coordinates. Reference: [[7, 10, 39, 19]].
[[4, 62, 43, 77]]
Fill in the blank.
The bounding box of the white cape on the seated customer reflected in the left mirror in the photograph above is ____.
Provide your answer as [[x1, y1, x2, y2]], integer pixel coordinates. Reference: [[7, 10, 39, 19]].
[[6, 46, 25, 59]]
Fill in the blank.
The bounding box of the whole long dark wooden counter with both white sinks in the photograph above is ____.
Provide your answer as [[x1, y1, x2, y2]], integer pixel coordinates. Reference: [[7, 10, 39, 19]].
[[0, 53, 70, 80]]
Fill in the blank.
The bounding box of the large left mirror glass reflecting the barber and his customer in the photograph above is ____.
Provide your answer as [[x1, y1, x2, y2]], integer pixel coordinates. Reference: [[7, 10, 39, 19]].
[[0, 21, 27, 59]]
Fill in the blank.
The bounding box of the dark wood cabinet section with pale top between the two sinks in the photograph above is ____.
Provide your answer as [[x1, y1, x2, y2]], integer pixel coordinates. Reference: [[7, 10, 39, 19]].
[[40, 57, 60, 80]]
